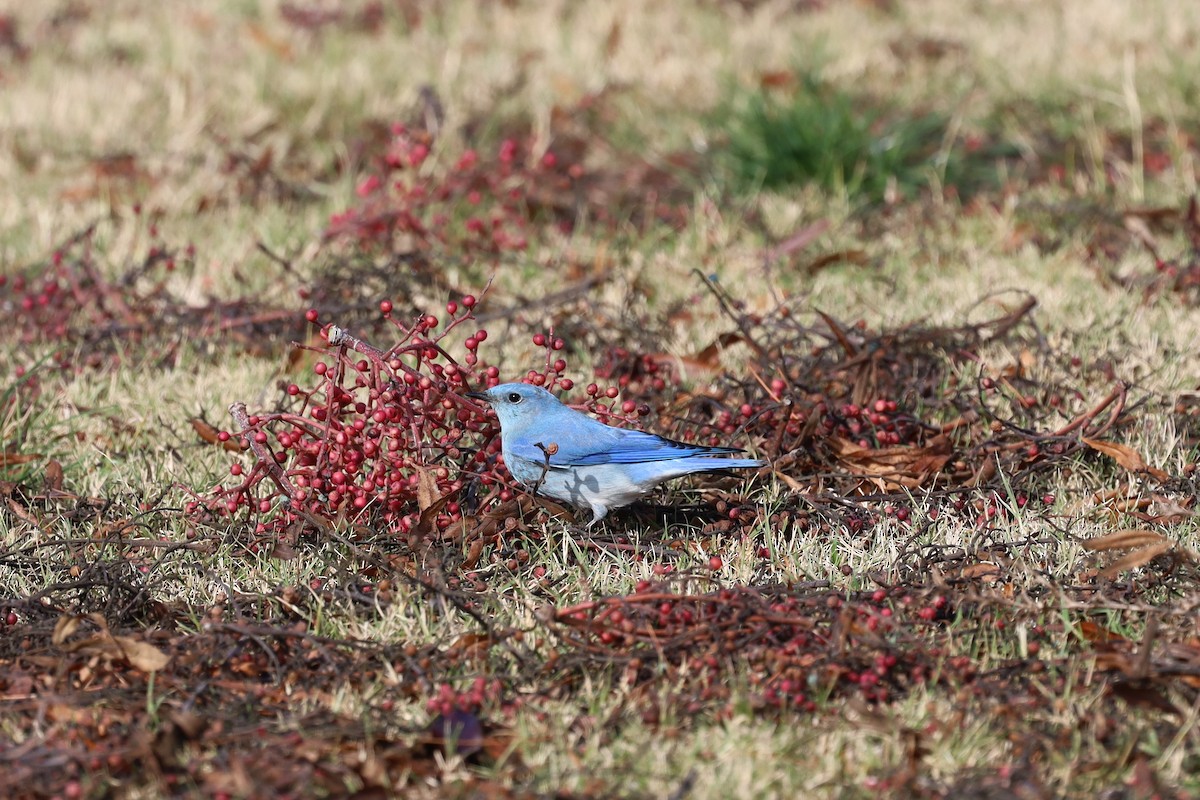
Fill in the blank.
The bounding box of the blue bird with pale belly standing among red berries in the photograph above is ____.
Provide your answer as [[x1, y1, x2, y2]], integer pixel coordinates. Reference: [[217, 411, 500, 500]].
[[467, 384, 766, 528]]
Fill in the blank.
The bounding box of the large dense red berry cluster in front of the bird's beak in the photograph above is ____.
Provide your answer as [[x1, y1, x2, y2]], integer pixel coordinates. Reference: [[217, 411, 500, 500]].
[[190, 295, 506, 533]]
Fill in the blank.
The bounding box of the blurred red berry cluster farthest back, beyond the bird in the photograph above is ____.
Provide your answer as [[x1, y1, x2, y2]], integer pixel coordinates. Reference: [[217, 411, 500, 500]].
[[325, 125, 582, 258]]
